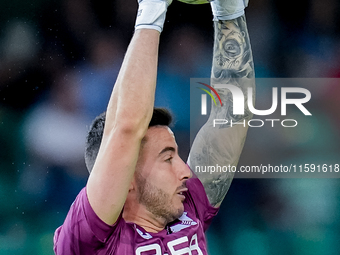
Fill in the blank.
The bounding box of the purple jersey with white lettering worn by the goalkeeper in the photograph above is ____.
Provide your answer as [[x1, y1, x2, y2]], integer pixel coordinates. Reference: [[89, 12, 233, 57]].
[[54, 177, 218, 255]]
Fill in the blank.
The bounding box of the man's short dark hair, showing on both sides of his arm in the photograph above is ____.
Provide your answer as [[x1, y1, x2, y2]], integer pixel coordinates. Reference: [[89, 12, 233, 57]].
[[85, 107, 172, 173]]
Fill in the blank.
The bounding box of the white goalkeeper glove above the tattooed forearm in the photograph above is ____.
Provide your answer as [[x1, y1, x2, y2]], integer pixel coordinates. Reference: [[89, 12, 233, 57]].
[[210, 0, 249, 21]]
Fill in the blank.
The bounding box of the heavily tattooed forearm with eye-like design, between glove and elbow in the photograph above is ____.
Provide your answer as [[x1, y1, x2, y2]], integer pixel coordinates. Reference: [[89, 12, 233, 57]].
[[210, 16, 255, 124]]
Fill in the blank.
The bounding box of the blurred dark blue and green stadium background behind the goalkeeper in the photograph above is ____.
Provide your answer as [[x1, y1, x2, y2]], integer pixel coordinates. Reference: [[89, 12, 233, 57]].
[[0, 0, 340, 255]]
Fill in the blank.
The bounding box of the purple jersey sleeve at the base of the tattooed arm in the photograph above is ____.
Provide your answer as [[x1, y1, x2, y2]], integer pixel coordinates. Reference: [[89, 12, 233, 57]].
[[185, 171, 219, 231]]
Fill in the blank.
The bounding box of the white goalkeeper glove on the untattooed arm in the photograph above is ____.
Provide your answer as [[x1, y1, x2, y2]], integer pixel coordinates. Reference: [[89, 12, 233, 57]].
[[135, 0, 172, 32]]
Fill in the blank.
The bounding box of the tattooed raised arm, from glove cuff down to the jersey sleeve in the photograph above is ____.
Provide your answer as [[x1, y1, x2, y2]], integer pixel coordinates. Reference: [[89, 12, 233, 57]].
[[188, 0, 255, 207]]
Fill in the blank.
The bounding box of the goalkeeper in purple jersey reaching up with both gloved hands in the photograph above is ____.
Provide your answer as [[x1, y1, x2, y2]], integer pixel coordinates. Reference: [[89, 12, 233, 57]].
[[54, 0, 254, 255]]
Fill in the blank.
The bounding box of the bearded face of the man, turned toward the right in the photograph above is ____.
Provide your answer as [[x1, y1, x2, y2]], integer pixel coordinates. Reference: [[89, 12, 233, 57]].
[[135, 126, 191, 222]]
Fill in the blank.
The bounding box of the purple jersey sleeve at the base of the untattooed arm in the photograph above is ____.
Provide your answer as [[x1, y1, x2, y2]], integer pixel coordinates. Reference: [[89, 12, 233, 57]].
[[53, 187, 122, 255]]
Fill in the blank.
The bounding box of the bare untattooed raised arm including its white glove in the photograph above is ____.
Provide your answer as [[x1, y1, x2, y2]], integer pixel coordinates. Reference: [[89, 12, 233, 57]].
[[87, 0, 168, 224]]
